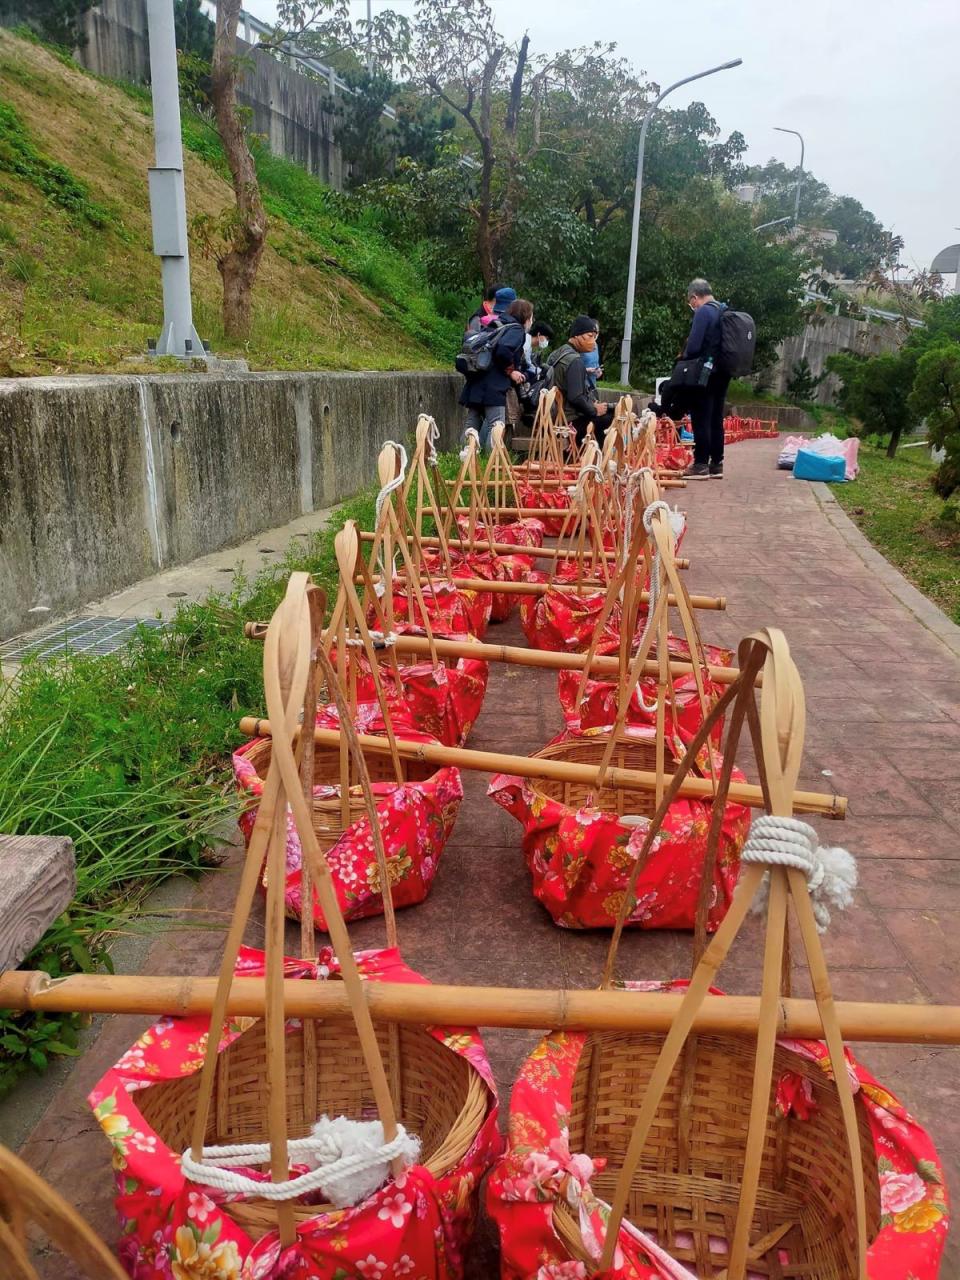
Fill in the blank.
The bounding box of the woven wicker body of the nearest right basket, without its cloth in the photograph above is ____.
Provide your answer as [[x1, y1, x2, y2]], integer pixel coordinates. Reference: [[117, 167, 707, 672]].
[[554, 1033, 879, 1280]]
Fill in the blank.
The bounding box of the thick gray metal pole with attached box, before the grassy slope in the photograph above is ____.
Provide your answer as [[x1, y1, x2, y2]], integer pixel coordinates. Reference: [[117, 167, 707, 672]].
[[147, 0, 204, 357]]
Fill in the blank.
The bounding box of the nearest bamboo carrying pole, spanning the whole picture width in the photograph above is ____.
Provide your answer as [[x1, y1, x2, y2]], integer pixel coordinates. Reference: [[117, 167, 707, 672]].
[[0, 969, 960, 1044]]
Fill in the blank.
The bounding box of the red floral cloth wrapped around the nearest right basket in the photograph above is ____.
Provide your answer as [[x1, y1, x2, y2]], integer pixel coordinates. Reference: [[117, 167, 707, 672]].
[[486, 982, 948, 1280]]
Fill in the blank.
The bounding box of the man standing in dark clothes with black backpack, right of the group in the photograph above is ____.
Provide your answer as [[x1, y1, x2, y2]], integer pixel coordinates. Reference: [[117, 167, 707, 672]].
[[675, 278, 756, 480]]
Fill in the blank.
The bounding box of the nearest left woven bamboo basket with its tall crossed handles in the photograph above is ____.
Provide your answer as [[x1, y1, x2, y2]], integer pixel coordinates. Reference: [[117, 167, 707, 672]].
[[137, 573, 492, 1244]]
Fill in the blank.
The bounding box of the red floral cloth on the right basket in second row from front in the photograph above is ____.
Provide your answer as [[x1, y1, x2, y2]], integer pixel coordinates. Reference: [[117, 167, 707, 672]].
[[486, 727, 750, 929]]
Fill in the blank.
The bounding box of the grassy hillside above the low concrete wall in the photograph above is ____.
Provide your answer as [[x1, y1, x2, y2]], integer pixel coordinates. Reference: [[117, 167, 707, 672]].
[[0, 31, 460, 375]]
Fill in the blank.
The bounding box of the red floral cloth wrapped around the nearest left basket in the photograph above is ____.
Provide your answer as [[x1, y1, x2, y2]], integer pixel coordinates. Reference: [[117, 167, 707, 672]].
[[88, 947, 502, 1280]]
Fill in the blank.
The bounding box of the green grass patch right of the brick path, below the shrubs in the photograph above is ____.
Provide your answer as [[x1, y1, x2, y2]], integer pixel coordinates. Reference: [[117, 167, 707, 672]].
[[833, 445, 960, 623]]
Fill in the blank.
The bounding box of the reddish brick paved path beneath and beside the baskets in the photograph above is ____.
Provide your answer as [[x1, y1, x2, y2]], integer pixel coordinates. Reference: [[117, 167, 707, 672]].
[[16, 442, 960, 1280]]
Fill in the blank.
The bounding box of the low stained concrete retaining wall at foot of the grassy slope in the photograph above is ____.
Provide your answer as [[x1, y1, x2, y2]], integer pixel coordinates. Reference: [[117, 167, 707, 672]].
[[0, 372, 462, 639]]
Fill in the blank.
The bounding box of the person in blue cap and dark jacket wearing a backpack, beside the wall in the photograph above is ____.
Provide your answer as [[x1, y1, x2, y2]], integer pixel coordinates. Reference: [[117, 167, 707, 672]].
[[457, 298, 534, 449]]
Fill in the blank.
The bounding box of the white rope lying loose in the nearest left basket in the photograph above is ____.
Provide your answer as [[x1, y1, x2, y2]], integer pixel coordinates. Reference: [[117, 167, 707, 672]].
[[180, 1117, 420, 1208]]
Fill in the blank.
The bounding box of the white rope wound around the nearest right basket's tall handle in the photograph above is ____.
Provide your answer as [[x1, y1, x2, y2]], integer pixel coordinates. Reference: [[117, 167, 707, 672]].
[[741, 814, 856, 933]]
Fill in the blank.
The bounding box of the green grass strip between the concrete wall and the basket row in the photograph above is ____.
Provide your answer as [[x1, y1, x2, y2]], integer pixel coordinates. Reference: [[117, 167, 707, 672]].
[[0, 454, 460, 1097]]
